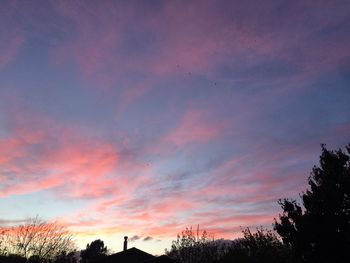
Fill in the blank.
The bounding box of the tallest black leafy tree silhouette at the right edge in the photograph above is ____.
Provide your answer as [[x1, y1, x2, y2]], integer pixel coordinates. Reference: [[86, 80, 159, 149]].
[[274, 144, 350, 263]]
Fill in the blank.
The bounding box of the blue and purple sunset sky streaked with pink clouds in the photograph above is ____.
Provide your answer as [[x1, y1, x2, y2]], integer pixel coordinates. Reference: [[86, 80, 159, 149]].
[[0, 0, 350, 254]]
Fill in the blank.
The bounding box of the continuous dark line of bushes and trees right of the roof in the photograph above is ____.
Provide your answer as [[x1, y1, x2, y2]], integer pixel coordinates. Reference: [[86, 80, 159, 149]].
[[167, 144, 350, 263]]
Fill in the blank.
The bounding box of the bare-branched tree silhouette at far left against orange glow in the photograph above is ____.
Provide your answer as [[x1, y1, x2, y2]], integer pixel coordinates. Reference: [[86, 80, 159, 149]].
[[0, 217, 75, 262]]
